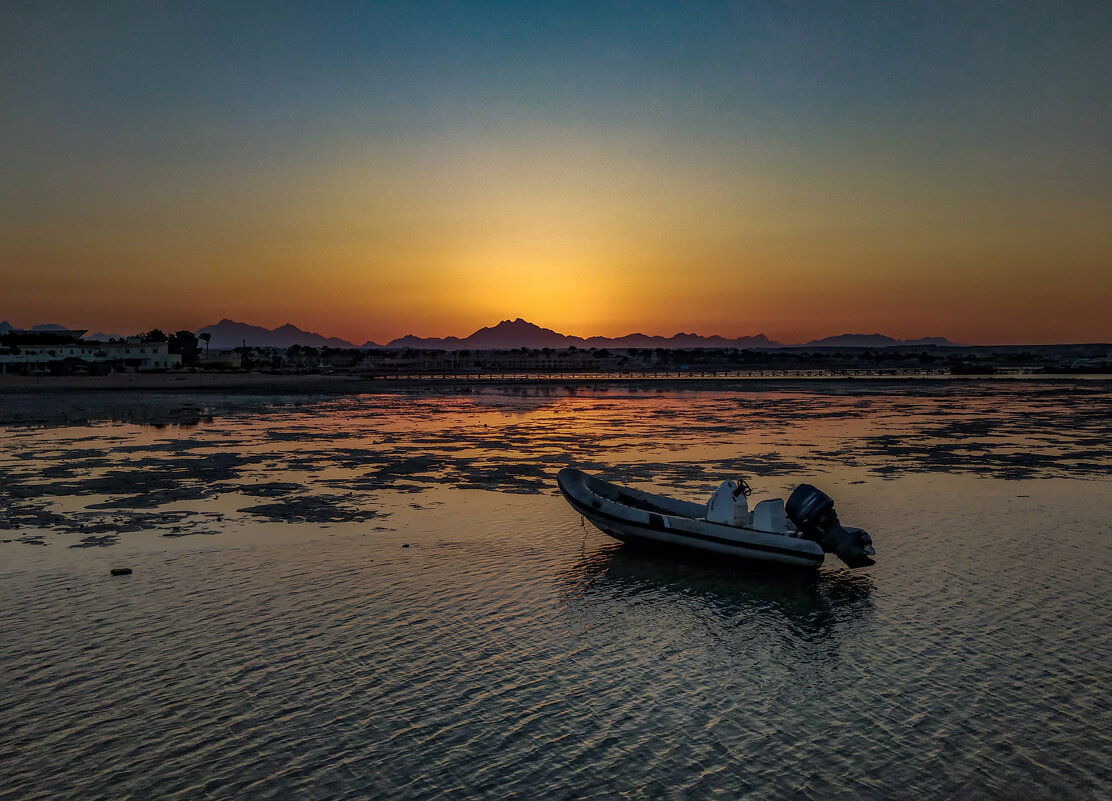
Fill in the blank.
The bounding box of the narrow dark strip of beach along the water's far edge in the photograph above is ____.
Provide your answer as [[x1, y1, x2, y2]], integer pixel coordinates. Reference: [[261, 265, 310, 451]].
[[0, 373, 1112, 395]]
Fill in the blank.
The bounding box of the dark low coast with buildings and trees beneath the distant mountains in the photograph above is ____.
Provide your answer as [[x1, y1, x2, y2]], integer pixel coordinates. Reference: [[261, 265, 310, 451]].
[[0, 320, 1112, 388]]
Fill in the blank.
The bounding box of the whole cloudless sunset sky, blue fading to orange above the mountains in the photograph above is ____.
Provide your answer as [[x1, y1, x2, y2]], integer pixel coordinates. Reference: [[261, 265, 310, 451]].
[[0, 0, 1112, 344]]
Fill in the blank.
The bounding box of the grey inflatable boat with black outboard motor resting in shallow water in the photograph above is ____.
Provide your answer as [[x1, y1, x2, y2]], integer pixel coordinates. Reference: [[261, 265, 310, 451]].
[[556, 467, 876, 567]]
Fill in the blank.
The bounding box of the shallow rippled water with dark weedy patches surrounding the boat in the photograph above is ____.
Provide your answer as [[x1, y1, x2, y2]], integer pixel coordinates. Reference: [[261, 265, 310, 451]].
[[0, 382, 1112, 800]]
